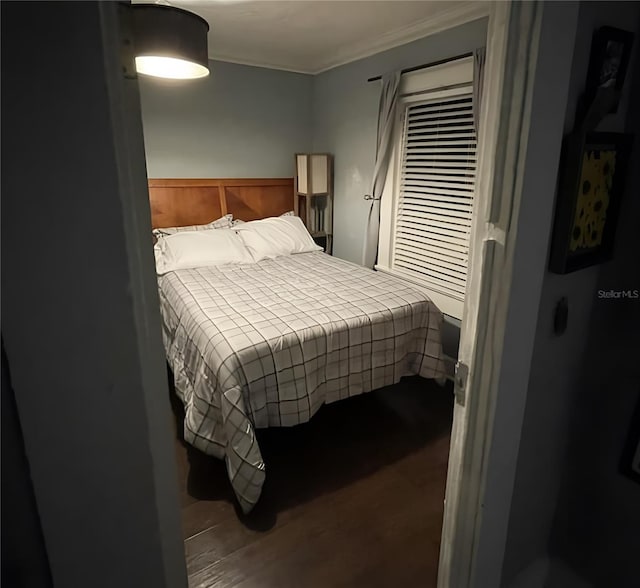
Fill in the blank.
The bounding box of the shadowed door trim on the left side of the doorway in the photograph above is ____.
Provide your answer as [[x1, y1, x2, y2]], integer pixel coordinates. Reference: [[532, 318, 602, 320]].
[[100, 3, 188, 588]]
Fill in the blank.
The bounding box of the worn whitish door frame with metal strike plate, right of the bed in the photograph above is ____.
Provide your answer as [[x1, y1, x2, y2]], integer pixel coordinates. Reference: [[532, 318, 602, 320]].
[[438, 1, 539, 588]]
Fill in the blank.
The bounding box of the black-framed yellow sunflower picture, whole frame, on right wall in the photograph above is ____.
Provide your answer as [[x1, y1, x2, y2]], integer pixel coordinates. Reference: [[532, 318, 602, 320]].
[[549, 133, 632, 274]]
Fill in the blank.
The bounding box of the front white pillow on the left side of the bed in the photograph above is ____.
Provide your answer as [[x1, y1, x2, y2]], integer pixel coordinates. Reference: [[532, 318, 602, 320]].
[[154, 229, 253, 275]]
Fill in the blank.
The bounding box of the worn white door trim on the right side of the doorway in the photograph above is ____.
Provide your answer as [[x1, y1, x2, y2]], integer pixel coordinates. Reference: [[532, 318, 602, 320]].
[[438, 1, 542, 588]]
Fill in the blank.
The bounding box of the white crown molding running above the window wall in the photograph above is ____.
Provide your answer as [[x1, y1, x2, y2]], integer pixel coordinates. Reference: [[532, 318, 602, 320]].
[[311, 0, 491, 75]]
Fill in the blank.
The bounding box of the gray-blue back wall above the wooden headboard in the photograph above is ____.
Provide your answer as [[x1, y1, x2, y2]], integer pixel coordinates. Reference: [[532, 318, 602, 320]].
[[140, 61, 312, 178]]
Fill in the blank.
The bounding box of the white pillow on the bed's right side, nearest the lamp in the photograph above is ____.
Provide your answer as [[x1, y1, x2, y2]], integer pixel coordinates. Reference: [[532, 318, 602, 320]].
[[234, 216, 322, 261]]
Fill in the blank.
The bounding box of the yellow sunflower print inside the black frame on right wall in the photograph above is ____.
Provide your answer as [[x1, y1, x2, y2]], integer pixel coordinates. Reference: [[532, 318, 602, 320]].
[[569, 150, 616, 253]]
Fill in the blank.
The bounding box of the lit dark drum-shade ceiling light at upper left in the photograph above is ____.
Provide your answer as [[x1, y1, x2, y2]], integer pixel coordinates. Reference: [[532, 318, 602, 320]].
[[131, 4, 209, 80]]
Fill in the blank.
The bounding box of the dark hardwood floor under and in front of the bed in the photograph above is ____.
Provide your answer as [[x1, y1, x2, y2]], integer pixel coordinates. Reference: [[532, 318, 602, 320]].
[[173, 378, 453, 588]]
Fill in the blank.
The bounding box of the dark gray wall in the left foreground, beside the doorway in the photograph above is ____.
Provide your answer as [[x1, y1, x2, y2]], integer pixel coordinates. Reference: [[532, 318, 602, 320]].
[[1, 2, 187, 588]]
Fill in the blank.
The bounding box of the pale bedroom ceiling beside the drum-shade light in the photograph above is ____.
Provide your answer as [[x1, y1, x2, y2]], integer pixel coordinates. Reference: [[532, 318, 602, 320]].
[[134, 0, 487, 74]]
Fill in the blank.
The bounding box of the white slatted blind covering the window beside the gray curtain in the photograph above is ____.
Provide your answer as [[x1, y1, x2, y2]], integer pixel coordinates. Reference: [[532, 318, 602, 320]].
[[393, 94, 476, 300]]
